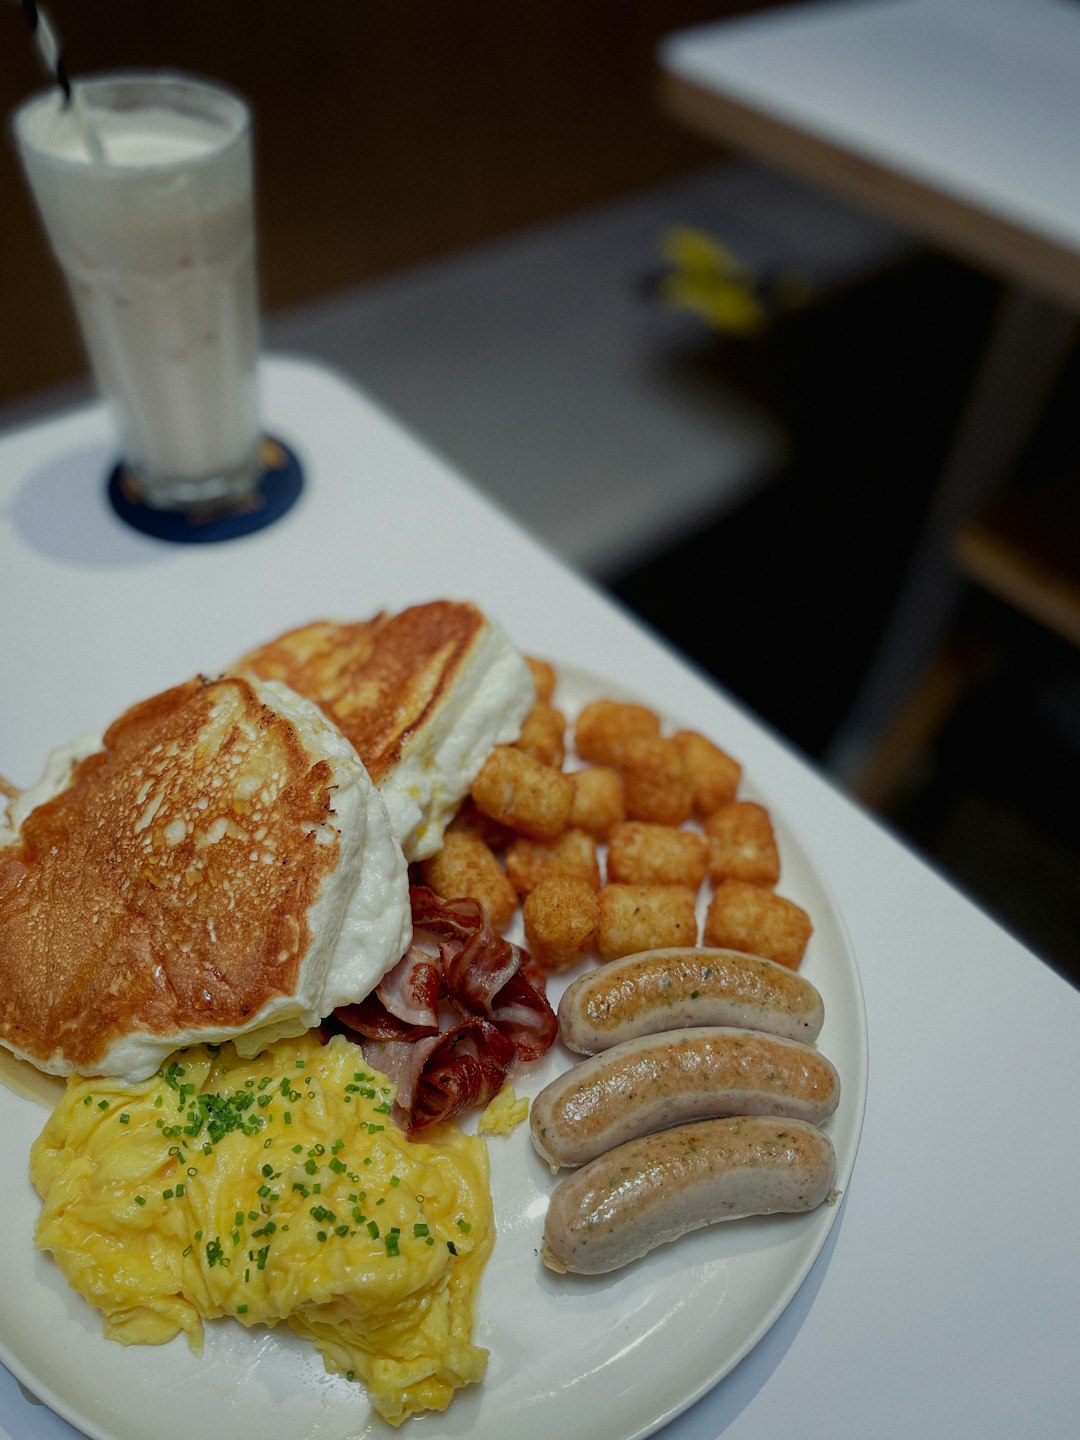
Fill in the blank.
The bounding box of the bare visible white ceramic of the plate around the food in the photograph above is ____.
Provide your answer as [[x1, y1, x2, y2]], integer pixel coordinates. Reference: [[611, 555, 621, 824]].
[[0, 667, 867, 1440]]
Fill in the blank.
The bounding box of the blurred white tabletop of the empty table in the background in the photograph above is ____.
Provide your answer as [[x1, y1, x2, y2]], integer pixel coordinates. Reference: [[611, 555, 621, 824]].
[[660, 0, 1080, 306]]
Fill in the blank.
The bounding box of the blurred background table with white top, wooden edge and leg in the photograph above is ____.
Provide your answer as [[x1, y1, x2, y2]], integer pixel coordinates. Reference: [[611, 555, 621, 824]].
[[660, 0, 1080, 779]]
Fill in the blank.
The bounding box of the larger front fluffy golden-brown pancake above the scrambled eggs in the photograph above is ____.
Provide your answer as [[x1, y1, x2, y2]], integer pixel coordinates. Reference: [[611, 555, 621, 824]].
[[0, 677, 412, 1080]]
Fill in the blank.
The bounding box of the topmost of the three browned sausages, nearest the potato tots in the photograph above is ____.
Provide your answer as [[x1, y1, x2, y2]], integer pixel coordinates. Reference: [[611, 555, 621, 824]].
[[559, 946, 825, 1056]]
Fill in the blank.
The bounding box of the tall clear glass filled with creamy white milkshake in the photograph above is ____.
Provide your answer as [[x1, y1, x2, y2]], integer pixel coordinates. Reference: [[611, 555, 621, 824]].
[[14, 72, 259, 513]]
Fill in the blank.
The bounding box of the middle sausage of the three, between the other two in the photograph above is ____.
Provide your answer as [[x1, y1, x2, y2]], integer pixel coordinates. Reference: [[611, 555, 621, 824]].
[[530, 1025, 840, 1168]]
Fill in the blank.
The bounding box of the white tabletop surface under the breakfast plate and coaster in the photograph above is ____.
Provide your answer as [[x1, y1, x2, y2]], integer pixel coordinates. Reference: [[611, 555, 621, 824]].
[[0, 351, 1080, 1440]]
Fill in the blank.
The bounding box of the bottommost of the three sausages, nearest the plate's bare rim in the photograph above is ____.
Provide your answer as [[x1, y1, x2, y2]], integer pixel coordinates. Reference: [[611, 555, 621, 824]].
[[540, 1116, 837, 1274]]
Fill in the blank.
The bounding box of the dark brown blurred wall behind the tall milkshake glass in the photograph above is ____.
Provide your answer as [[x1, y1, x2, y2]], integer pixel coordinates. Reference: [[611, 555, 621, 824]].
[[0, 0, 783, 402]]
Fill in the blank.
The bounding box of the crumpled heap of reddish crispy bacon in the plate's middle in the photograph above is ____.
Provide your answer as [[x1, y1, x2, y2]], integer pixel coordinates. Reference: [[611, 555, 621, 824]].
[[334, 886, 559, 1133]]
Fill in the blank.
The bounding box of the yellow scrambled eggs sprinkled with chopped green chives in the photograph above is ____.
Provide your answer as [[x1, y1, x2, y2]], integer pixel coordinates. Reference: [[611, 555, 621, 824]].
[[30, 1037, 494, 1424]]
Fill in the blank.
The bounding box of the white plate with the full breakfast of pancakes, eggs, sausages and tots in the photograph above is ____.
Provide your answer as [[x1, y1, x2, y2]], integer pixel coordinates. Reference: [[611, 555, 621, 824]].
[[0, 600, 867, 1440]]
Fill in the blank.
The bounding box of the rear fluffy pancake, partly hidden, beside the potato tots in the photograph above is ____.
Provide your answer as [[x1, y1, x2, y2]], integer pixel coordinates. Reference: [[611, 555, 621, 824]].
[[236, 600, 536, 861]]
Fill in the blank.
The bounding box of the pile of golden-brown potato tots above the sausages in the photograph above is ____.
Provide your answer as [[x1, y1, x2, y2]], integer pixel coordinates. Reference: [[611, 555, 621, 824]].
[[422, 658, 812, 971]]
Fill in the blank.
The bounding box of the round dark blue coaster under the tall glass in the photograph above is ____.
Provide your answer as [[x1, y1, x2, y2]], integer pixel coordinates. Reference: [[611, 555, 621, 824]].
[[108, 436, 304, 544]]
